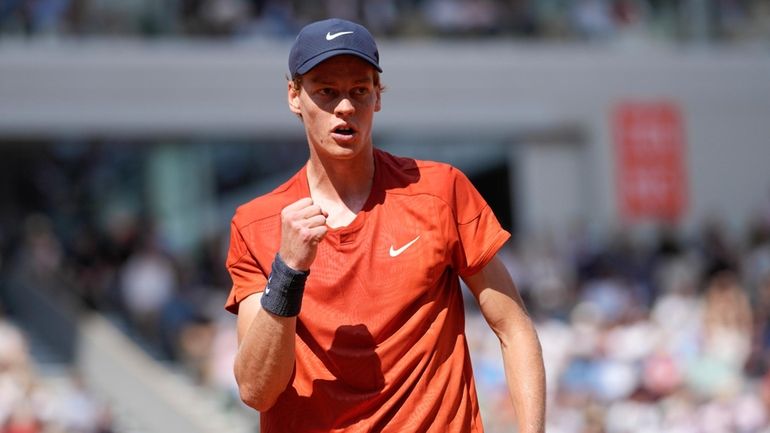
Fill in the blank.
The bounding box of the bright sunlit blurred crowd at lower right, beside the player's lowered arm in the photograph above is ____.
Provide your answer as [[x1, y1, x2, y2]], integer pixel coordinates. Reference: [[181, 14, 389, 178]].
[[468, 209, 770, 433]]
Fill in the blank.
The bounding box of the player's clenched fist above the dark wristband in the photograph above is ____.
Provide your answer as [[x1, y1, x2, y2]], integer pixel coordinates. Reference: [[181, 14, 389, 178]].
[[278, 197, 329, 271]]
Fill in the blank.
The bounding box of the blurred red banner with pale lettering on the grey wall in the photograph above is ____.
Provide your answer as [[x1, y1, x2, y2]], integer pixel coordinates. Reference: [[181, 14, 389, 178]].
[[612, 102, 687, 221]]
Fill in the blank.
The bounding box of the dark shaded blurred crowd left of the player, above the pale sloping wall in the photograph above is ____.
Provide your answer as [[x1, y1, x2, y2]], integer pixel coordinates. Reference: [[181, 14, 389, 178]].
[[0, 143, 229, 362]]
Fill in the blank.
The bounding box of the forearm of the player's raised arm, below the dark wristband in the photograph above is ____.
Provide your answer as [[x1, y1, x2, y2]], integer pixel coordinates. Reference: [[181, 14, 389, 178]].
[[234, 296, 297, 411]]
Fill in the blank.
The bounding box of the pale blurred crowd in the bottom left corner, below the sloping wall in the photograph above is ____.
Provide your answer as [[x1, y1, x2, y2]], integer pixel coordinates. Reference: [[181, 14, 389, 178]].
[[0, 317, 114, 433]]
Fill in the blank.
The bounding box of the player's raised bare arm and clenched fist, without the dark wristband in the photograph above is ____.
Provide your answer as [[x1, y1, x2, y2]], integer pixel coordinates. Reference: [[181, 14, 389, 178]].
[[228, 198, 327, 411]]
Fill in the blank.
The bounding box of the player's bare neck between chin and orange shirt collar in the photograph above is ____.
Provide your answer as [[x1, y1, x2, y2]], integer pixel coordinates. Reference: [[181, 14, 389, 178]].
[[307, 151, 374, 216]]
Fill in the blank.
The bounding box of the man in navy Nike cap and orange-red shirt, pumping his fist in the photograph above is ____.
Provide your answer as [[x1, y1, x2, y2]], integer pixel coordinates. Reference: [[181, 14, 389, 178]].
[[226, 19, 545, 433]]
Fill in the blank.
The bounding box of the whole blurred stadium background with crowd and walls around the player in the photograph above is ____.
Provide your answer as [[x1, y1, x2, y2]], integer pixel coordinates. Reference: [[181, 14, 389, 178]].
[[0, 0, 770, 433]]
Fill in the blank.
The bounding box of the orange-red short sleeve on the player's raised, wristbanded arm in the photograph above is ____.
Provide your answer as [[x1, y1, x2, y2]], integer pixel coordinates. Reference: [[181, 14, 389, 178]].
[[225, 222, 267, 314]]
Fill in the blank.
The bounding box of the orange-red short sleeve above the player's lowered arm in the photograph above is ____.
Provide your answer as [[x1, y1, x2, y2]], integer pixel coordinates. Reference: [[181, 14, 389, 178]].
[[444, 169, 511, 276]]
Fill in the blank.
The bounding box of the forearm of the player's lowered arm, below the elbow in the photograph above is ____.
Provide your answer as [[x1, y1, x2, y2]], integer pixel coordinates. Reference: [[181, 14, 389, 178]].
[[500, 324, 545, 433]]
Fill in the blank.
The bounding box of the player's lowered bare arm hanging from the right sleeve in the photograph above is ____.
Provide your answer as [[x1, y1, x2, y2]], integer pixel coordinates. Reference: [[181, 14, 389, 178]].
[[464, 257, 545, 433]]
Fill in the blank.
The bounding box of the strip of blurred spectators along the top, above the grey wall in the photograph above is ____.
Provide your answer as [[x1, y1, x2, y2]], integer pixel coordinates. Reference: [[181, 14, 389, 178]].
[[0, 0, 770, 41]]
